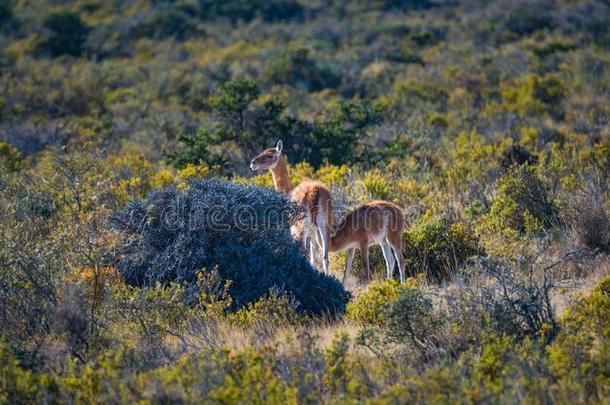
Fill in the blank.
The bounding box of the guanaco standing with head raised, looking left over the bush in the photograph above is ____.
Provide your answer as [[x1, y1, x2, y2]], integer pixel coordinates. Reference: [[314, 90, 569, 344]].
[[250, 140, 333, 274]]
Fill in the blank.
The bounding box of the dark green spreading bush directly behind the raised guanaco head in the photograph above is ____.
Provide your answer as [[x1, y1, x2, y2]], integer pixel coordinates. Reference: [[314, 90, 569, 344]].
[[166, 80, 383, 173]]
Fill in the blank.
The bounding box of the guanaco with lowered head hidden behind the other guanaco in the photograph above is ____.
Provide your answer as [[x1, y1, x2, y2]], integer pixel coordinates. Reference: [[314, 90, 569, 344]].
[[330, 201, 405, 283]]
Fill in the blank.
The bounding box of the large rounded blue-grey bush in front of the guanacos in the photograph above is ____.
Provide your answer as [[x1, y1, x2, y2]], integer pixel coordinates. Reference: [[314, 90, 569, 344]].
[[113, 180, 348, 315]]
